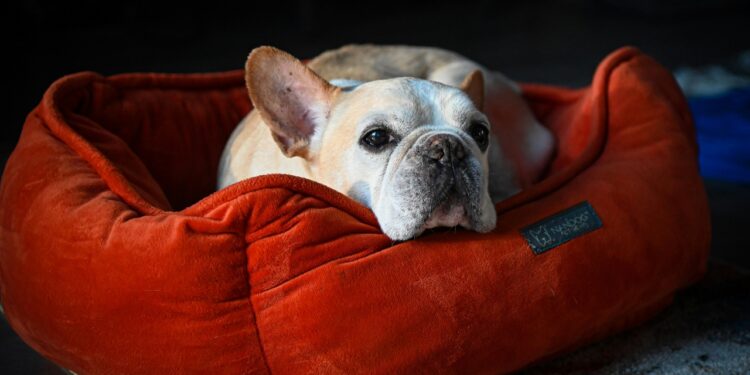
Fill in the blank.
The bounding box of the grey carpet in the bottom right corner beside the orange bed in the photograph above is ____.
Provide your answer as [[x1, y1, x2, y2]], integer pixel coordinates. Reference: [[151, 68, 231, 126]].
[[523, 261, 750, 375]]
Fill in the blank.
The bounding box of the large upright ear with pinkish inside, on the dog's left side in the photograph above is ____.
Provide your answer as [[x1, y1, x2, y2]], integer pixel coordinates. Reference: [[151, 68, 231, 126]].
[[245, 47, 337, 158]]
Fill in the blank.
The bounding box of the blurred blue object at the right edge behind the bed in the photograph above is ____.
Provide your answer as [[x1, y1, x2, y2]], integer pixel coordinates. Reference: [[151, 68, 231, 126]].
[[688, 87, 750, 183]]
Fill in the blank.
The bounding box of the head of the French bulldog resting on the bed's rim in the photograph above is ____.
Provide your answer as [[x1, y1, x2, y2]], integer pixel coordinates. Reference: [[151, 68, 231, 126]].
[[246, 47, 516, 240]]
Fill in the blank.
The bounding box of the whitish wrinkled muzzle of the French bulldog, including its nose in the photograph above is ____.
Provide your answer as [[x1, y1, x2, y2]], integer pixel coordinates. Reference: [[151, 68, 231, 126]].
[[374, 132, 495, 239]]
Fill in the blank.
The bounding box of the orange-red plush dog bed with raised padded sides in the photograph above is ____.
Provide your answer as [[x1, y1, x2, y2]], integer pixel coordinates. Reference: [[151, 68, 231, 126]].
[[0, 48, 710, 374]]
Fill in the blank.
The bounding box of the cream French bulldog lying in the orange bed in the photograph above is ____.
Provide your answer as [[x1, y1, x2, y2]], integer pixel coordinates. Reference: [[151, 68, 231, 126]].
[[218, 45, 555, 240]]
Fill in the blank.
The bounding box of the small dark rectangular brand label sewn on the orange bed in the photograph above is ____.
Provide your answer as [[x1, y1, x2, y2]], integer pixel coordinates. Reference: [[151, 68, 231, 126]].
[[521, 201, 602, 255]]
